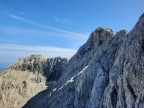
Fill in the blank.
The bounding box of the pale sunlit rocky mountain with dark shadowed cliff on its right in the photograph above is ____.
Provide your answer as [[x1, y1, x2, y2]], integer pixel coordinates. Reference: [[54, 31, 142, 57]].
[[0, 55, 67, 108]]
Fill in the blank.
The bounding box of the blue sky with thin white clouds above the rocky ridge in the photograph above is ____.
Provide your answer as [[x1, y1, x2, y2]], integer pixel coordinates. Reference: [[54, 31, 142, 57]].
[[0, 0, 144, 64]]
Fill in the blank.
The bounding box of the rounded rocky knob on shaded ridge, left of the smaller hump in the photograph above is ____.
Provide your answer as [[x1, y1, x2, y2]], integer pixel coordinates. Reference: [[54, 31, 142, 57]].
[[75, 27, 114, 57]]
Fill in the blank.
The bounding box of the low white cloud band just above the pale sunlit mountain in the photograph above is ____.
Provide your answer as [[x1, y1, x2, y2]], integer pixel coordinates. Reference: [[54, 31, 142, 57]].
[[0, 44, 76, 64]]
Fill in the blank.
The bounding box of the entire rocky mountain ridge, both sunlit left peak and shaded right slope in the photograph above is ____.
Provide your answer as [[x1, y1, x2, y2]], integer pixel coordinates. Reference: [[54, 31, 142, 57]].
[[0, 14, 144, 108]]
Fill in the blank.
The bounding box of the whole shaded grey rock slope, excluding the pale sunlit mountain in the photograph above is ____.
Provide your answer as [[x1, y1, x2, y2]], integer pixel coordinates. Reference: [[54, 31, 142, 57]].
[[24, 14, 144, 108]]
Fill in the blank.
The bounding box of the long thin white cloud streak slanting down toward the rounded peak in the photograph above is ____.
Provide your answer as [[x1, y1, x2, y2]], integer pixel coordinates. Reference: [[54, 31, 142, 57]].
[[7, 13, 83, 36]]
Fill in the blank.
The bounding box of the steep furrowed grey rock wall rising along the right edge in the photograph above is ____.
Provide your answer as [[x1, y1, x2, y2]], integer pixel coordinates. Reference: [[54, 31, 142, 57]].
[[101, 14, 144, 108]]
